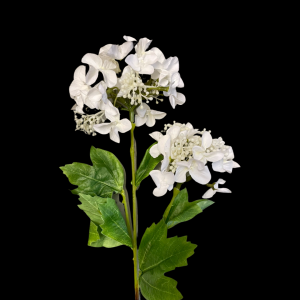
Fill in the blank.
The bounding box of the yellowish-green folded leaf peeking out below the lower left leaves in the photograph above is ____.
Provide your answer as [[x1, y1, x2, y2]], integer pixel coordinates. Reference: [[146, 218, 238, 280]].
[[88, 221, 122, 248]]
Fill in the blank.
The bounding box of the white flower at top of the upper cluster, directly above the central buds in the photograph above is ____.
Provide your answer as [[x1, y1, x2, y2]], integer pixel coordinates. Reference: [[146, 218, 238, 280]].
[[125, 38, 158, 74]]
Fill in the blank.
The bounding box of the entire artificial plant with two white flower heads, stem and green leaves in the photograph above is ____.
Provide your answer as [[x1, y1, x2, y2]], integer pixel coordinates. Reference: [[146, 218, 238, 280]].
[[61, 36, 240, 300]]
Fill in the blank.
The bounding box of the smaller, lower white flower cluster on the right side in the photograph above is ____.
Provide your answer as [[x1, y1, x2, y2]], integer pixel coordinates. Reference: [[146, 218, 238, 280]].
[[150, 122, 240, 198]]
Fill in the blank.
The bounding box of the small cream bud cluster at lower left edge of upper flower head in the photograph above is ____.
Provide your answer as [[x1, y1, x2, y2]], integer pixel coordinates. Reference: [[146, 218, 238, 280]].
[[74, 111, 106, 136]]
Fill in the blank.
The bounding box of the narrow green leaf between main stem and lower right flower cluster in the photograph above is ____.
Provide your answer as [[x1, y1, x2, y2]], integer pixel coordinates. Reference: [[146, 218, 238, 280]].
[[135, 143, 163, 187]]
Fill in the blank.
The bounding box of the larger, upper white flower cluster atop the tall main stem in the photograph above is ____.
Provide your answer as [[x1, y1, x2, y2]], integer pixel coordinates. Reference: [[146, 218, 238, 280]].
[[69, 36, 185, 143]]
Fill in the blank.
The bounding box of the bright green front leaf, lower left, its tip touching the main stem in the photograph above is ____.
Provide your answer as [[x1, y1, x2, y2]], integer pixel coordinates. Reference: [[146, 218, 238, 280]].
[[99, 198, 132, 248]]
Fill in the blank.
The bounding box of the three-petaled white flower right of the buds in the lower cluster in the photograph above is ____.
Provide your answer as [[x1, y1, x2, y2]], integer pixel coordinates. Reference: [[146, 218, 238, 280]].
[[193, 131, 224, 164]]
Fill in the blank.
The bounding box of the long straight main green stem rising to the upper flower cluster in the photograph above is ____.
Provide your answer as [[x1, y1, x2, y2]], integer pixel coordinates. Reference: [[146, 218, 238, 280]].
[[130, 110, 140, 300]]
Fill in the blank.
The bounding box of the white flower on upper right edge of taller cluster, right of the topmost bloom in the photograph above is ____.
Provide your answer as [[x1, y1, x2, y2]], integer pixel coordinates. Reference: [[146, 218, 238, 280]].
[[151, 56, 179, 86]]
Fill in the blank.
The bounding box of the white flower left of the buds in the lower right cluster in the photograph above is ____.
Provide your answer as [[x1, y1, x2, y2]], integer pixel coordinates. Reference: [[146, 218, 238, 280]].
[[150, 125, 180, 171]]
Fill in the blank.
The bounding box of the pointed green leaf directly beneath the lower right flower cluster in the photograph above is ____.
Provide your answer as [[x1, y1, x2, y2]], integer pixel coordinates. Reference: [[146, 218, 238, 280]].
[[166, 189, 214, 229]]
